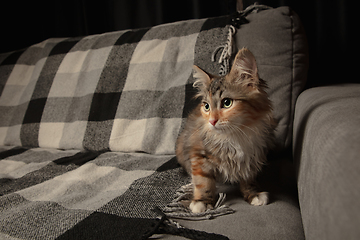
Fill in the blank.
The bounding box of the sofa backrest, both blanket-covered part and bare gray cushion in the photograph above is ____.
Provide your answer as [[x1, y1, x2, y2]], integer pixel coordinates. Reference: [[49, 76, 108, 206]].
[[0, 7, 307, 154]]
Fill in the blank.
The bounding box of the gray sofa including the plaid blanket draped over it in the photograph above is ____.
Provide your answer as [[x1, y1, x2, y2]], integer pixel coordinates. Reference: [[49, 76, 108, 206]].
[[0, 5, 360, 239]]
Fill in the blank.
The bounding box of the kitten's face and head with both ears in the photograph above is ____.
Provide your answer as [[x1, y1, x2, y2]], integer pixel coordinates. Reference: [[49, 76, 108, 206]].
[[194, 49, 271, 132]]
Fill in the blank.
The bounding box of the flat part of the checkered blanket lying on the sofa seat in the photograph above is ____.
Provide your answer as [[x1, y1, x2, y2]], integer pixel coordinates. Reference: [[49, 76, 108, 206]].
[[0, 148, 189, 239]]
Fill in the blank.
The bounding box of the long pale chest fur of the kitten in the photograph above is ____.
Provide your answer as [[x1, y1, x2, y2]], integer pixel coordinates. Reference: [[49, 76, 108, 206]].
[[203, 129, 265, 182]]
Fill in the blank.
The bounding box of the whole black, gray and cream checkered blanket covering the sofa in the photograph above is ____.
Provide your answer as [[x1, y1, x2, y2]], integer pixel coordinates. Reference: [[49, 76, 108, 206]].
[[0, 17, 231, 239]]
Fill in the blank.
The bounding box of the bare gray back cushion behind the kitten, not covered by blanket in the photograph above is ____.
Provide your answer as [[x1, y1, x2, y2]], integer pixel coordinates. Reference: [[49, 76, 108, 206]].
[[236, 7, 308, 149]]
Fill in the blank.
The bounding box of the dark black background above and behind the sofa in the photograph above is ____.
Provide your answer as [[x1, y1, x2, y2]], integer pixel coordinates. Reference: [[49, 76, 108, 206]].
[[0, 0, 354, 87]]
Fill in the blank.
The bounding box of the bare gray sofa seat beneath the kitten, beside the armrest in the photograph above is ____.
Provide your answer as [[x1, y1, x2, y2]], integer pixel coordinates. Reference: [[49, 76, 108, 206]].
[[176, 154, 305, 240]]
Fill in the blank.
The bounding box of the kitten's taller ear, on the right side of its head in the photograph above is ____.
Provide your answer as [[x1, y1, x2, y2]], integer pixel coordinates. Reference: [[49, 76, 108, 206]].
[[229, 48, 259, 90]]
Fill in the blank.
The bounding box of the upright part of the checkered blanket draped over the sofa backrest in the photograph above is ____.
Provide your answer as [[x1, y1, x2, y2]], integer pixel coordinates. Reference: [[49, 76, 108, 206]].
[[0, 17, 229, 154]]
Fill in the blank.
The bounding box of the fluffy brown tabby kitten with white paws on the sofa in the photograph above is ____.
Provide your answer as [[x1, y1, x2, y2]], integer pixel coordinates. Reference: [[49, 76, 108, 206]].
[[176, 48, 273, 213]]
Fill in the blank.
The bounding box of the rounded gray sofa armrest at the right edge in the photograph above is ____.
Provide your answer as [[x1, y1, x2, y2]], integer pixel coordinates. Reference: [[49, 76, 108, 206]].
[[293, 84, 360, 239]]
